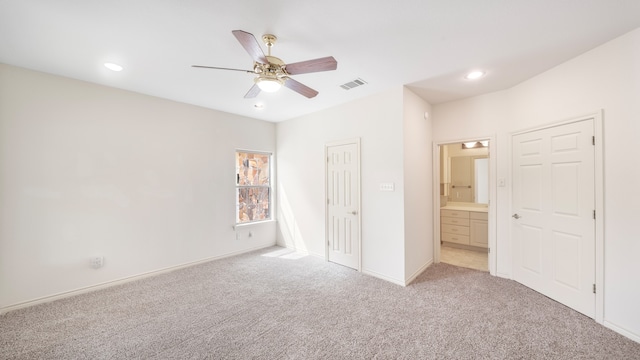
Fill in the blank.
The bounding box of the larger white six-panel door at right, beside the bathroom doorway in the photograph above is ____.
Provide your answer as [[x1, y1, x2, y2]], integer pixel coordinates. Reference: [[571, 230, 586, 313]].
[[512, 119, 595, 317]]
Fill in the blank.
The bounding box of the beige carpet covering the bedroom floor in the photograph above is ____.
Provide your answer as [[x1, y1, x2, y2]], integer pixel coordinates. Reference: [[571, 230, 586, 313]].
[[0, 248, 640, 359]]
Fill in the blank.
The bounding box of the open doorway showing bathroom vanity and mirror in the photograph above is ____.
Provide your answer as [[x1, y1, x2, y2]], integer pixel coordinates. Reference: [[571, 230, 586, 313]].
[[434, 137, 496, 274]]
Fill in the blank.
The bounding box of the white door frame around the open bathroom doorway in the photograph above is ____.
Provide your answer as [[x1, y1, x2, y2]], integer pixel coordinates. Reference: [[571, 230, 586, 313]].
[[433, 134, 498, 276]]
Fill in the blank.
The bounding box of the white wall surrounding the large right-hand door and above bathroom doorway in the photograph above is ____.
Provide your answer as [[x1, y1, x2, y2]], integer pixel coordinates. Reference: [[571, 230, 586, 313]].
[[433, 29, 640, 341]]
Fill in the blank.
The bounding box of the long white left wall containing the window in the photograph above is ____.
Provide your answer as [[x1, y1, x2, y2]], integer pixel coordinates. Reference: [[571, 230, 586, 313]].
[[0, 65, 275, 311]]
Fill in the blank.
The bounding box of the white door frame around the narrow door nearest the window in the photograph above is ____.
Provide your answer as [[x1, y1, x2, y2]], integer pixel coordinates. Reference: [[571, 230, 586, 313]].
[[324, 137, 362, 272]]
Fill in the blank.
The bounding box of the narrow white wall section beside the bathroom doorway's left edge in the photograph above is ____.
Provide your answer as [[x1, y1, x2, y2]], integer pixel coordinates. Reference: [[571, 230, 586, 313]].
[[403, 88, 434, 283]]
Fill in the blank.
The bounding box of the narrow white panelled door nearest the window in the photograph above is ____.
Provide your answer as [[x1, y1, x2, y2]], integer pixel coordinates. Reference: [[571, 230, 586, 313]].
[[326, 142, 360, 270]]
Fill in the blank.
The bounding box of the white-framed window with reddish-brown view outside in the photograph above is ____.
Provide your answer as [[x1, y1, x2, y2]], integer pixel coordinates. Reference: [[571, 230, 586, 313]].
[[236, 151, 271, 224]]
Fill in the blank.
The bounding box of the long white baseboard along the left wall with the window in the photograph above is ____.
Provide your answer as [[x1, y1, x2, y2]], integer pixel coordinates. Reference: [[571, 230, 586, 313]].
[[0, 244, 275, 315]]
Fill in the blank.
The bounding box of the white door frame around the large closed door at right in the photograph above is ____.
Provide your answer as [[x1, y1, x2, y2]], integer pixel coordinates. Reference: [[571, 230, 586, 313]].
[[507, 109, 605, 324]]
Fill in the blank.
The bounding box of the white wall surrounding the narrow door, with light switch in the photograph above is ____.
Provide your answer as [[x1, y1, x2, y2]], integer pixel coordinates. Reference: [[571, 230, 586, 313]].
[[276, 87, 405, 284]]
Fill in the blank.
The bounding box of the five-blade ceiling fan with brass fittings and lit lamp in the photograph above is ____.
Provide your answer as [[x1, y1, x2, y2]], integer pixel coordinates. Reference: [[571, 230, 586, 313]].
[[192, 30, 338, 99]]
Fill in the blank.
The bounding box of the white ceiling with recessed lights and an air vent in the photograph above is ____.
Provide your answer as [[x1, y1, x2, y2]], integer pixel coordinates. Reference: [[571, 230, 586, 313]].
[[0, 0, 640, 122]]
